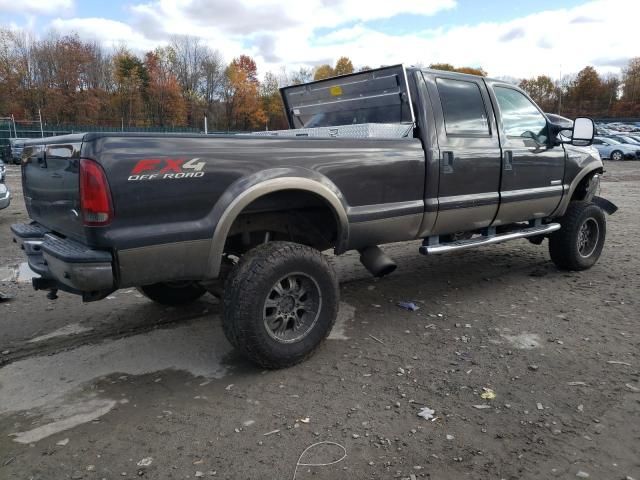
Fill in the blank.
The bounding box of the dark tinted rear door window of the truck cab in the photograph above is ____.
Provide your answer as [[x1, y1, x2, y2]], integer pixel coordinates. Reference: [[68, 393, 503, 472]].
[[436, 78, 491, 136]]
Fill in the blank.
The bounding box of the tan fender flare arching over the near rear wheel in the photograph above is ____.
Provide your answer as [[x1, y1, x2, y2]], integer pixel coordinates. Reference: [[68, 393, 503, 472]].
[[207, 168, 349, 278]]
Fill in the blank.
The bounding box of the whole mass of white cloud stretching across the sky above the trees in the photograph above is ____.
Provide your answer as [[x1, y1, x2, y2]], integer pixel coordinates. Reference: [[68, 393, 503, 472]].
[[38, 0, 640, 77]]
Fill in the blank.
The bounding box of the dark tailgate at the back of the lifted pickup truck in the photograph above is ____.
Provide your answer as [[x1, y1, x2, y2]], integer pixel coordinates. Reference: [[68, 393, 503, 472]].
[[22, 135, 84, 241]]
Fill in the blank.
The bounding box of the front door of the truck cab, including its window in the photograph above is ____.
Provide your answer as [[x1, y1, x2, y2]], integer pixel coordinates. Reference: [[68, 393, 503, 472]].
[[487, 81, 565, 225]]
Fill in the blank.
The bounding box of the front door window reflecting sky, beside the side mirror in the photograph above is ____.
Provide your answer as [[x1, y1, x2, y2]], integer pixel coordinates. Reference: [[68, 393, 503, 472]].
[[495, 87, 547, 144]]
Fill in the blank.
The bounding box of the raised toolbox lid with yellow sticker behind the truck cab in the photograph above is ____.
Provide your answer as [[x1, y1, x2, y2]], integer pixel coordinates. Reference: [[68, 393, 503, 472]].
[[280, 65, 414, 128]]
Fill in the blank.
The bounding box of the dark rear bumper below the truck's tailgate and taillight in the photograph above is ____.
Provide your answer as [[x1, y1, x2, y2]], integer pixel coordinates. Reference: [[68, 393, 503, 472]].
[[11, 223, 115, 294]]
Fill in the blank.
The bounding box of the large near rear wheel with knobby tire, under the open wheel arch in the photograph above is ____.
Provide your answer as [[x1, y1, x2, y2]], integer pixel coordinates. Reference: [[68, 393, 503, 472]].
[[223, 242, 339, 369]]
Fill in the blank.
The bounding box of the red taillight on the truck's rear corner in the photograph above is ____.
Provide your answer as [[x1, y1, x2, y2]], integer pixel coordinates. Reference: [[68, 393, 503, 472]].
[[80, 158, 113, 227]]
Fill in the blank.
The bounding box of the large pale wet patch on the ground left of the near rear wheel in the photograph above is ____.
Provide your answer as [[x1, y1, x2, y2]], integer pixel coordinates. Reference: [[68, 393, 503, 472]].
[[0, 317, 231, 443]]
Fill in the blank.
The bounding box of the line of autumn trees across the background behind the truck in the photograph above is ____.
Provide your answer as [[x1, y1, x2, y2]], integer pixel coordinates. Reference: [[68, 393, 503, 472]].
[[5, 27, 640, 130]]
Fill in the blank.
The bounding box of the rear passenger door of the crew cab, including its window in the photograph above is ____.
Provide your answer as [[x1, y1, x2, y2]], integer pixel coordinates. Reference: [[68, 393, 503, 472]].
[[424, 72, 500, 234]]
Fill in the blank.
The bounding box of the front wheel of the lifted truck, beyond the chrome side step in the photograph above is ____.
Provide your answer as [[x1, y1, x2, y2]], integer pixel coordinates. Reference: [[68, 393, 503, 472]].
[[549, 202, 607, 270]]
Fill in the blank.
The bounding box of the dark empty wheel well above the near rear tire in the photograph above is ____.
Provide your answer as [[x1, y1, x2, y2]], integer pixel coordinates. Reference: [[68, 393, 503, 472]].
[[224, 190, 339, 255]]
